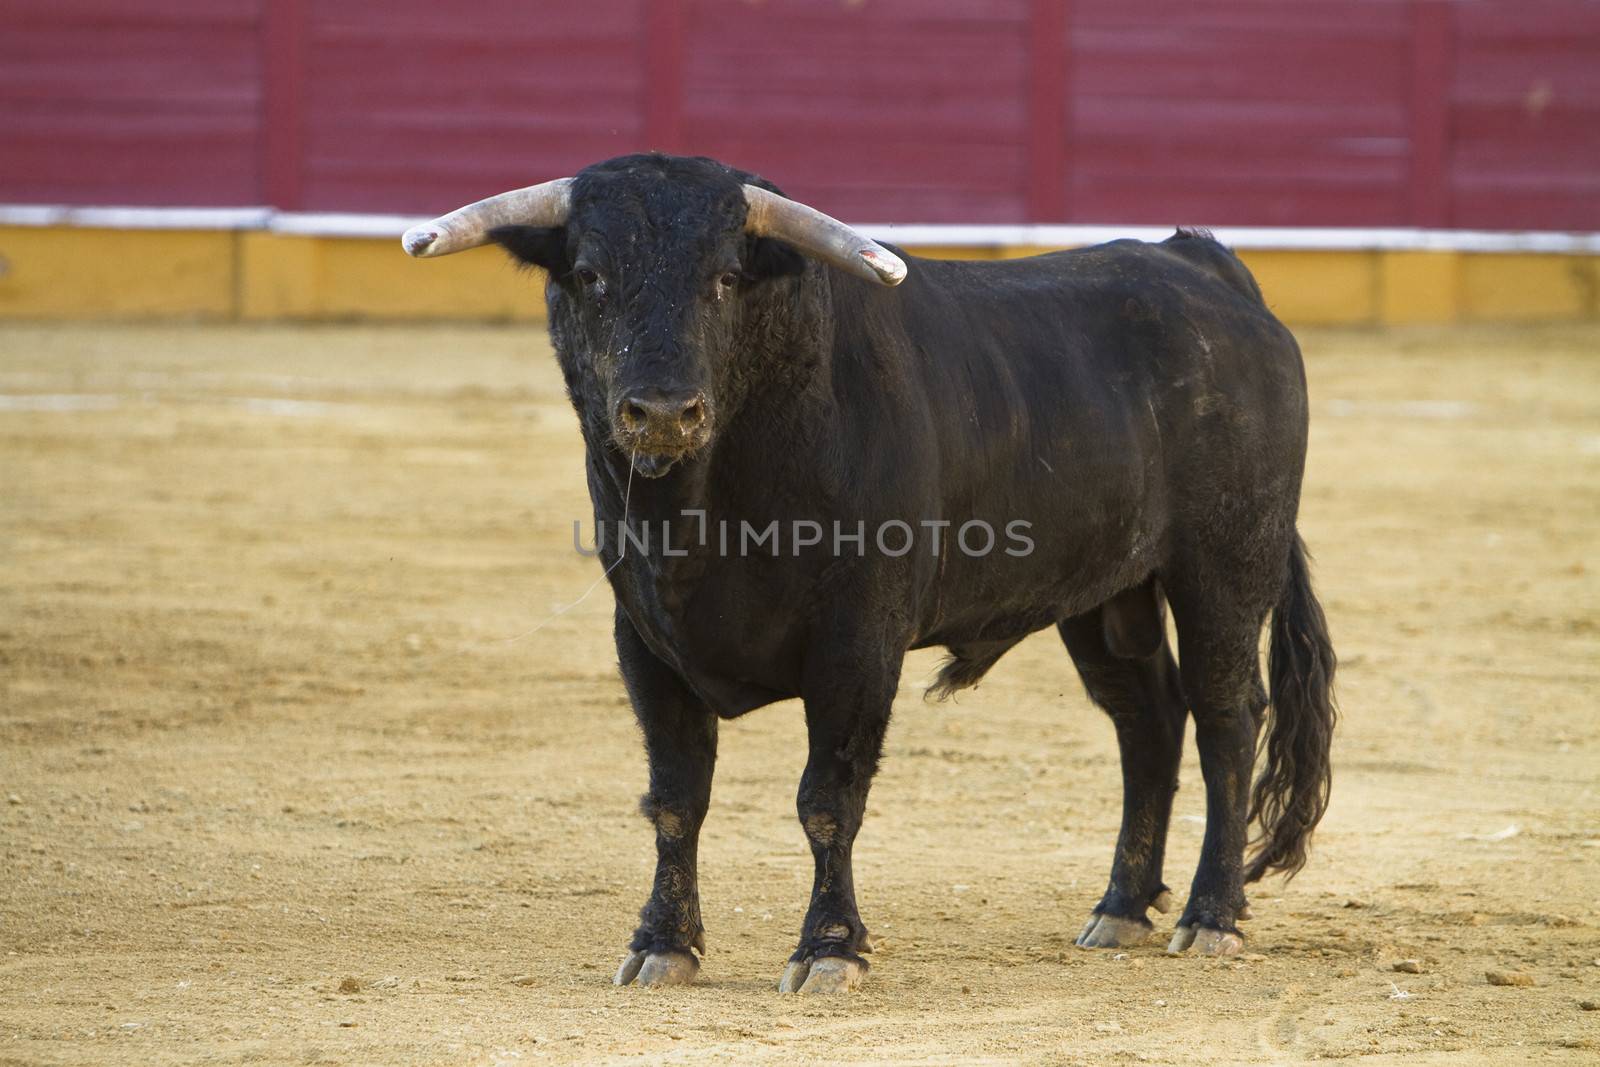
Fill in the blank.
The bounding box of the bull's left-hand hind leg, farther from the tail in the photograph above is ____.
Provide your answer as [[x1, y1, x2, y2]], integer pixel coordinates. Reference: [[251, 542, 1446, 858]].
[[1058, 584, 1186, 949]]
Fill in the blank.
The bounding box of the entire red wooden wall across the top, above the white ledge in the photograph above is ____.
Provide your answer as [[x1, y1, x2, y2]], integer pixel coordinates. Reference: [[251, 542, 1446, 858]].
[[0, 0, 1600, 230]]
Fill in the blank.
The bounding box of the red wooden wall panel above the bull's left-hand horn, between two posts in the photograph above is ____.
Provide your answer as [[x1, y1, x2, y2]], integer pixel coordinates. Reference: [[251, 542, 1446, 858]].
[[301, 0, 648, 214]]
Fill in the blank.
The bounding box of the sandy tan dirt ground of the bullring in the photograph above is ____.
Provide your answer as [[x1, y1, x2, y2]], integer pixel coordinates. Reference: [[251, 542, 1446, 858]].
[[0, 326, 1600, 1065]]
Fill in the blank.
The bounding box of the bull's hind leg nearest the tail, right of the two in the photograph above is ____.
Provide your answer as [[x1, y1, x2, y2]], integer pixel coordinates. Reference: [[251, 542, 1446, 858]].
[[1168, 585, 1270, 955]]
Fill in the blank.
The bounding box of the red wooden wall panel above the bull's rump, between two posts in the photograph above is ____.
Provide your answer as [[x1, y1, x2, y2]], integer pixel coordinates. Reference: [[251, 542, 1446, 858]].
[[1070, 0, 1411, 226]]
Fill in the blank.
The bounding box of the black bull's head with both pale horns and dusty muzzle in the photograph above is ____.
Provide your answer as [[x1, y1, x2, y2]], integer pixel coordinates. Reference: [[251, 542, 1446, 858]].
[[402, 155, 906, 477]]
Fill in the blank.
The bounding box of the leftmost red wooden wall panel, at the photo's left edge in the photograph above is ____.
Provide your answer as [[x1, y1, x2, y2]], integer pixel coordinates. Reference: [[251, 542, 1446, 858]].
[[0, 0, 262, 205]]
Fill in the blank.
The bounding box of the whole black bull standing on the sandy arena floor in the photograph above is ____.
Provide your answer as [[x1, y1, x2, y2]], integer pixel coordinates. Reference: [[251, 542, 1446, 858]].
[[406, 155, 1334, 992]]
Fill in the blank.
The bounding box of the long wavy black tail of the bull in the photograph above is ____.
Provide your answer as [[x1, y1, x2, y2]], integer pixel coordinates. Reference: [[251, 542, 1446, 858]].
[[1245, 534, 1338, 881]]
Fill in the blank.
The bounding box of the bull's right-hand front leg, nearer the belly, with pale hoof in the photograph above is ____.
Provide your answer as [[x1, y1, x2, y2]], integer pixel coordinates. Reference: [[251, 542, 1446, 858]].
[[778, 654, 901, 993]]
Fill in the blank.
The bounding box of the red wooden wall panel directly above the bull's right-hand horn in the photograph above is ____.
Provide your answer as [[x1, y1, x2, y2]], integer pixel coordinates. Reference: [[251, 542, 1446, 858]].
[[682, 0, 1024, 222]]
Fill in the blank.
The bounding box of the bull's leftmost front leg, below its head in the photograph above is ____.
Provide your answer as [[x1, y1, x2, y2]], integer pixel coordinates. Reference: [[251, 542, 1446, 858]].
[[614, 608, 717, 985]]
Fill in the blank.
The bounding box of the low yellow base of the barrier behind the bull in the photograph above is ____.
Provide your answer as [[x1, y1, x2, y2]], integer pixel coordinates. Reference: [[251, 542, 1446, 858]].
[[0, 226, 1600, 325]]
